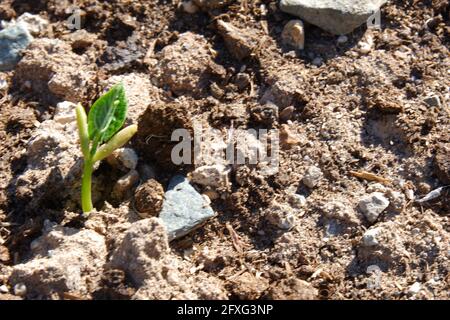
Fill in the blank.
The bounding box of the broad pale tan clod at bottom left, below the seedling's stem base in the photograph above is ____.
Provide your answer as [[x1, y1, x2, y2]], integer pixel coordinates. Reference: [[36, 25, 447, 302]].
[[9, 223, 107, 298]]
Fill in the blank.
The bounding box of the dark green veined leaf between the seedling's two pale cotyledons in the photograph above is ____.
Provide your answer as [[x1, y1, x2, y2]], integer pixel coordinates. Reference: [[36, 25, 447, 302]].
[[88, 83, 128, 144]]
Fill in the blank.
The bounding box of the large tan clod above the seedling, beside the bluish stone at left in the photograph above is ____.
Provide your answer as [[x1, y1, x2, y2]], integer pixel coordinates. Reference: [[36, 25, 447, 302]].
[[15, 38, 95, 103]]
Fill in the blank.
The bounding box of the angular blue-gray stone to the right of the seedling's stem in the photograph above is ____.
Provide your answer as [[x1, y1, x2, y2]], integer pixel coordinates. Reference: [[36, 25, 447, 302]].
[[159, 176, 215, 241]]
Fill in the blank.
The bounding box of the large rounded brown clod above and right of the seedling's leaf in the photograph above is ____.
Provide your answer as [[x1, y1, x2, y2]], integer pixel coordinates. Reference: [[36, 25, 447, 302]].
[[150, 32, 226, 96]]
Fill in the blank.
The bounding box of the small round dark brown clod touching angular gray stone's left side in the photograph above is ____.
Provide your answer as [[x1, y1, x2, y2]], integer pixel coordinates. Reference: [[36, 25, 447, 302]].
[[134, 179, 164, 218]]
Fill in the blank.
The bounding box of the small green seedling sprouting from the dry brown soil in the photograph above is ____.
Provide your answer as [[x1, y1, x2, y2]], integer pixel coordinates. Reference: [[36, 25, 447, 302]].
[[76, 84, 137, 215]]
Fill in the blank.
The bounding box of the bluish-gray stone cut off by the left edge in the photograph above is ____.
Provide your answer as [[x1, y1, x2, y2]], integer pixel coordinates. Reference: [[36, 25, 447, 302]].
[[0, 23, 33, 71]]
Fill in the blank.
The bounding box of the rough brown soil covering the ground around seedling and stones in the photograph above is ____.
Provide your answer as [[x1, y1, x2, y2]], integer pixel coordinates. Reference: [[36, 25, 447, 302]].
[[0, 0, 450, 299]]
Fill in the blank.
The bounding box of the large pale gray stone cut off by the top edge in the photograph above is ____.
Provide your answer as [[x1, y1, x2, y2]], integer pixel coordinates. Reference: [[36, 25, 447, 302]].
[[280, 0, 386, 35]]
